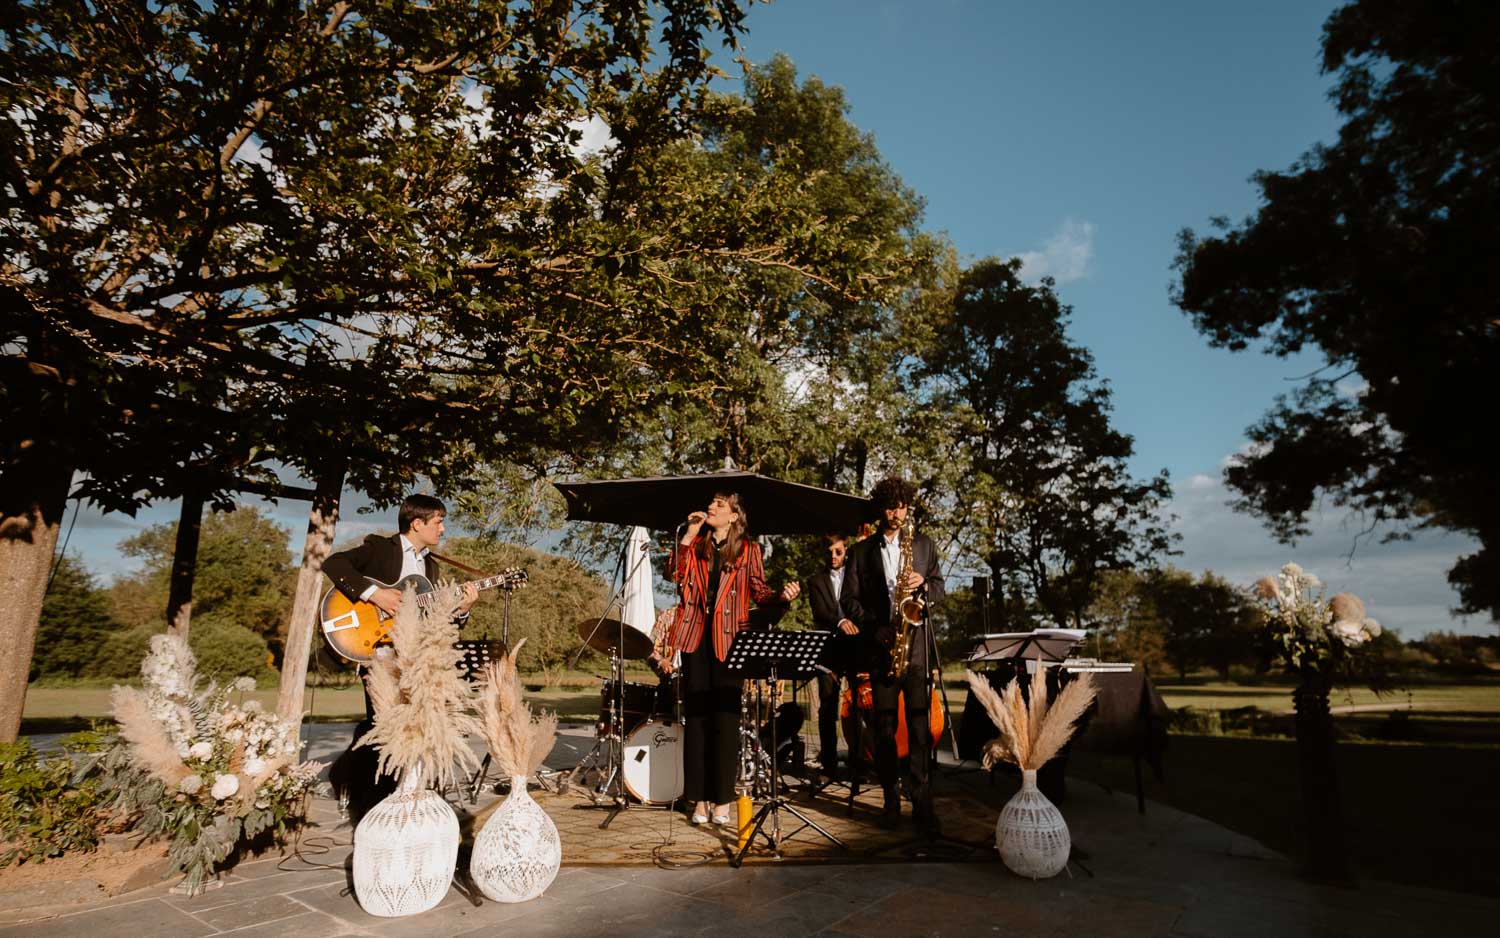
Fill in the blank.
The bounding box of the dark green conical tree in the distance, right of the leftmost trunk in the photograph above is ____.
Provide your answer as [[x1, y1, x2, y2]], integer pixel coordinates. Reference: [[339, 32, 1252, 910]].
[[30, 555, 120, 681]]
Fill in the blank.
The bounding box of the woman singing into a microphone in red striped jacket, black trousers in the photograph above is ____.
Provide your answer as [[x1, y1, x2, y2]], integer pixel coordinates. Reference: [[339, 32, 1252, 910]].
[[653, 492, 801, 825]]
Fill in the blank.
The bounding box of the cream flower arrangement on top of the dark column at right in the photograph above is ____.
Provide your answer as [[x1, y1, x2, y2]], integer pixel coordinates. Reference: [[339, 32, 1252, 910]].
[[1254, 563, 1380, 671]]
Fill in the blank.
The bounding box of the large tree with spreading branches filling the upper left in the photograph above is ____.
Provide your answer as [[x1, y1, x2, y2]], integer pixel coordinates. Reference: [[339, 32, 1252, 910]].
[[0, 0, 786, 737]]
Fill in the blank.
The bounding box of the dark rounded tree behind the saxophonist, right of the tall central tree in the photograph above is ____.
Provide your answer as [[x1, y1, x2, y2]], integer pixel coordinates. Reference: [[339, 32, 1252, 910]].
[[912, 260, 1173, 624]]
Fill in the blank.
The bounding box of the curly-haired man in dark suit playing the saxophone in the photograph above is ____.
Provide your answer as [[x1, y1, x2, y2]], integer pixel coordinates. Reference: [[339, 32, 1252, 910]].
[[845, 476, 944, 836]]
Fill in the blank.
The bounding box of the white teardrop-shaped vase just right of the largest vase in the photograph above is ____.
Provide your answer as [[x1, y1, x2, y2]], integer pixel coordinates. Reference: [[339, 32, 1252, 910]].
[[470, 776, 563, 902]]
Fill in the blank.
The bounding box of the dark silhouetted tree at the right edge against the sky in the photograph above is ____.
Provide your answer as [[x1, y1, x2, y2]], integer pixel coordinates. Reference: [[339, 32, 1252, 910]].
[[1173, 0, 1500, 617]]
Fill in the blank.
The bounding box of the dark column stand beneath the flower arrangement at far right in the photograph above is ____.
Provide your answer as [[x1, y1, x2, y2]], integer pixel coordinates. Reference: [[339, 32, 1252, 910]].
[[1293, 669, 1350, 882]]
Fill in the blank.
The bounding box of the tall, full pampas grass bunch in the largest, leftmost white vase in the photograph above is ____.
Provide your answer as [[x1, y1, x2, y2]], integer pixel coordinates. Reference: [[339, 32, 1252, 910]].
[[359, 584, 480, 786]]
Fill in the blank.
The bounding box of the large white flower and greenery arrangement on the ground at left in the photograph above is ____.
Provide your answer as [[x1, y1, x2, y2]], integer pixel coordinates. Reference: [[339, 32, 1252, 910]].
[[96, 633, 323, 891]]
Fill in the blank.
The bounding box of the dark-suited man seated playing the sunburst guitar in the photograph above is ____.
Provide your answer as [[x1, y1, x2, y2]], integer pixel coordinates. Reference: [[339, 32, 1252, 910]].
[[323, 494, 479, 827]]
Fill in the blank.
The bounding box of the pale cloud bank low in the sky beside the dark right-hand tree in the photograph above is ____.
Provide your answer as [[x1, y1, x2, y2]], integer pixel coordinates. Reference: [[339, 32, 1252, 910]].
[[1169, 462, 1494, 639]]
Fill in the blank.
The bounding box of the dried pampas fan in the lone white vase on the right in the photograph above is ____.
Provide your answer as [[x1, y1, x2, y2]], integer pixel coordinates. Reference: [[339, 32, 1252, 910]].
[[965, 666, 1097, 770]]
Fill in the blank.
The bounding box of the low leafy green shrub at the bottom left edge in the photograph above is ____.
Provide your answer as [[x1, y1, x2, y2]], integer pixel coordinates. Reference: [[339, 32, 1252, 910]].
[[0, 732, 111, 866]]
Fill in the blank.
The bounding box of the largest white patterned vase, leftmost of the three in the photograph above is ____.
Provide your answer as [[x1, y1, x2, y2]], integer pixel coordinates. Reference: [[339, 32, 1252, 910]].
[[354, 764, 459, 917]]
